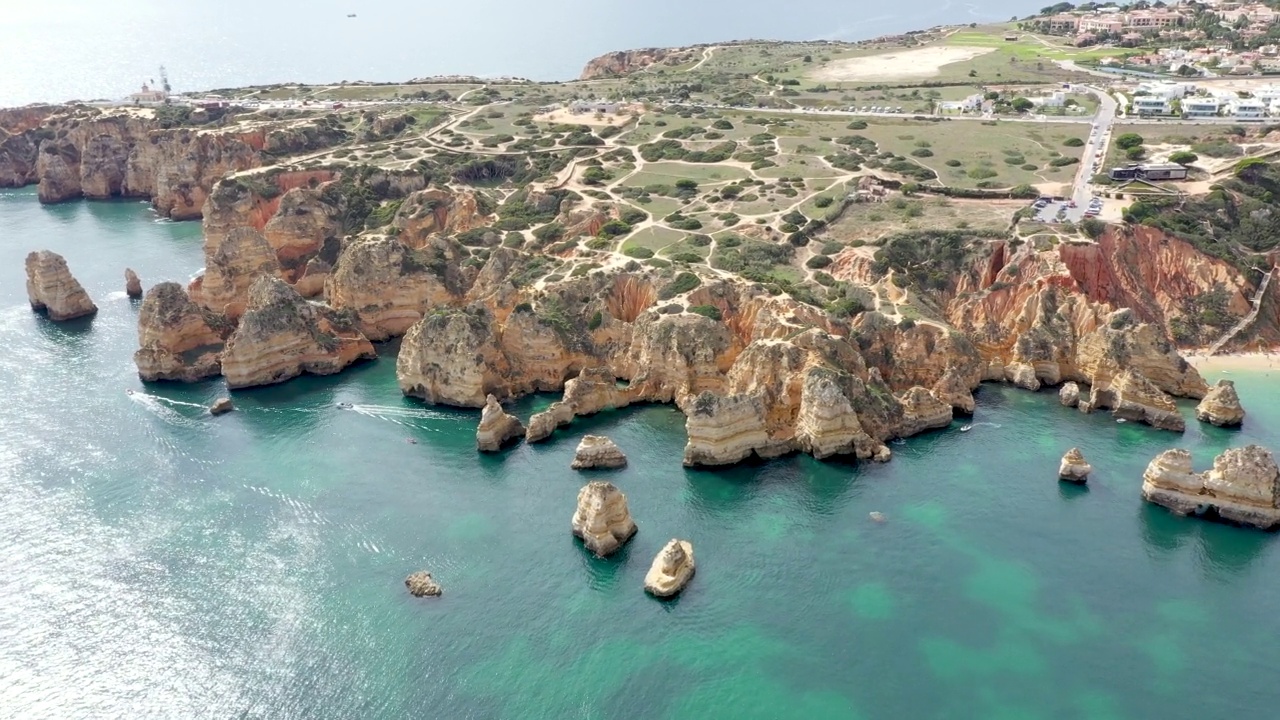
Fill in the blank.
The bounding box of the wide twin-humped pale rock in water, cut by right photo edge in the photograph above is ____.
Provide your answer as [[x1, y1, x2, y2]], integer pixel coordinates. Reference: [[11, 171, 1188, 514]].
[[1142, 445, 1280, 530]]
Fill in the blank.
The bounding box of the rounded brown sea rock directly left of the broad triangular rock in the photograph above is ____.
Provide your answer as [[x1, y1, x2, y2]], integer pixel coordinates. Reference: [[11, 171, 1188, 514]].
[[133, 282, 230, 383]]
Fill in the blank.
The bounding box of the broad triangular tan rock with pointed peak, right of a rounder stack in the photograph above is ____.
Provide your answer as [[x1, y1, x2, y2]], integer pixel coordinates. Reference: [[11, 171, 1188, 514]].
[[223, 275, 378, 388]]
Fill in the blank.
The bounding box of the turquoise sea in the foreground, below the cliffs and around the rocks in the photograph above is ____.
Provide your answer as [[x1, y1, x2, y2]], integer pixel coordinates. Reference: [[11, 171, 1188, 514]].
[[0, 190, 1280, 719]]
